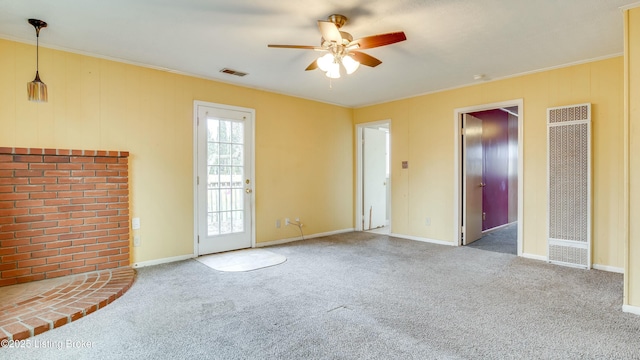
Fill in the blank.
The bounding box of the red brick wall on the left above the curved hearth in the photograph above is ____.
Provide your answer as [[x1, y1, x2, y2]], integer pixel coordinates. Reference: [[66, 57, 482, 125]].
[[0, 147, 129, 286]]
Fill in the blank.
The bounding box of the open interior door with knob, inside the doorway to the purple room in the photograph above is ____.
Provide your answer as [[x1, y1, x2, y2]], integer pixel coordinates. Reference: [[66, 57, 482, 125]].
[[462, 114, 484, 245]]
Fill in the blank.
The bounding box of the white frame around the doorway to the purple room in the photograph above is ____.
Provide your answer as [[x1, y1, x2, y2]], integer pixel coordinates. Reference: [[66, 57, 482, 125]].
[[453, 99, 524, 256]]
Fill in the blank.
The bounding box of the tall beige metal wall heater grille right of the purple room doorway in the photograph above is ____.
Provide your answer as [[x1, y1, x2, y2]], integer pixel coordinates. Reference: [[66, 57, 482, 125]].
[[547, 104, 591, 269]]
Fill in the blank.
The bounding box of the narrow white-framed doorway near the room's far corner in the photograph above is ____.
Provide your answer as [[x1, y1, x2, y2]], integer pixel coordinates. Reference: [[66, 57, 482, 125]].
[[356, 120, 391, 234]]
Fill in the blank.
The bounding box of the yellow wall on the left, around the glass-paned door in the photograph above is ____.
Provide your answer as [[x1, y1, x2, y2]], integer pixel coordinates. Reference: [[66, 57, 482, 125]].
[[0, 40, 353, 262]]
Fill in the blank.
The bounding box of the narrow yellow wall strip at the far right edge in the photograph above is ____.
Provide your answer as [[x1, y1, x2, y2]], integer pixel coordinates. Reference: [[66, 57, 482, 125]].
[[624, 8, 640, 308]]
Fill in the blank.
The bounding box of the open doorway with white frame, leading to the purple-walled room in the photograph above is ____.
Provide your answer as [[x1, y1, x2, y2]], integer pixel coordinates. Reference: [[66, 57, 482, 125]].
[[455, 100, 523, 255]]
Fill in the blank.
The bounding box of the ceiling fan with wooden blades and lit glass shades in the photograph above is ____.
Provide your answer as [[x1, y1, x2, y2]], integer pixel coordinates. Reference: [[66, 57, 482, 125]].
[[267, 14, 407, 79]]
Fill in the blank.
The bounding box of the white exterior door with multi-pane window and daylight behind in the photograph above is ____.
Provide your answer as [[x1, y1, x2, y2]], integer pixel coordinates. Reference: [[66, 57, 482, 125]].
[[196, 105, 253, 255]]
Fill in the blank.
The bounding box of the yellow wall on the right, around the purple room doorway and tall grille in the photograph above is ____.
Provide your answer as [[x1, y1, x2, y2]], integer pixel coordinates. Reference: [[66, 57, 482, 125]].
[[354, 57, 625, 268]]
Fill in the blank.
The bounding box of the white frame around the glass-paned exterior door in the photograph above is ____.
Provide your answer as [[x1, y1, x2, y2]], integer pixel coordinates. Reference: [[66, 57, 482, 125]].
[[192, 100, 256, 256]]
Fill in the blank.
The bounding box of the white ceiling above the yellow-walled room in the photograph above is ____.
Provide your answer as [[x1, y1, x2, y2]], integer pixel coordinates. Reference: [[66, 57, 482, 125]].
[[0, 0, 637, 107]]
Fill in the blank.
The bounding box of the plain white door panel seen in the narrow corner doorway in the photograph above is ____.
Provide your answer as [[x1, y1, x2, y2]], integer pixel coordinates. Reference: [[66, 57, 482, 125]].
[[362, 128, 387, 230]]
